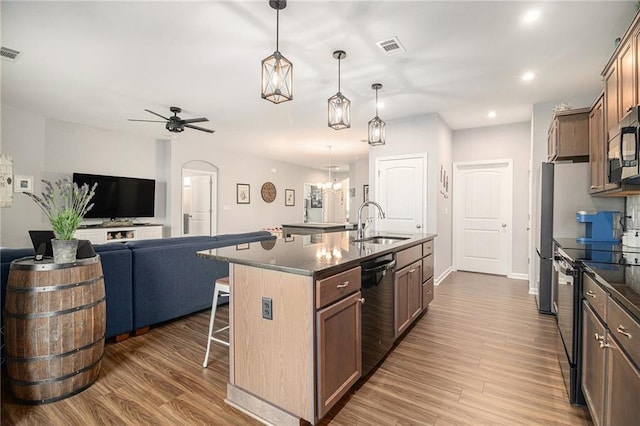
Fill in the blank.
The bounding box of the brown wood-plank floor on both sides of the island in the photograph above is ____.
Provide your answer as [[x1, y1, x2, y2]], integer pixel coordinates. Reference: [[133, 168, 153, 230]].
[[1, 272, 591, 426]]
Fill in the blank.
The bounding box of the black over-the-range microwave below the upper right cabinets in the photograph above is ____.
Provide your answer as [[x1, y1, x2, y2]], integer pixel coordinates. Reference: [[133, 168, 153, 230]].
[[607, 106, 640, 184]]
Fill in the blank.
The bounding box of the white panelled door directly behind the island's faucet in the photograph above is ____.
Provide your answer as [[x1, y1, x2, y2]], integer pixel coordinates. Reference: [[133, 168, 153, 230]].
[[376, 155, 426, 233]]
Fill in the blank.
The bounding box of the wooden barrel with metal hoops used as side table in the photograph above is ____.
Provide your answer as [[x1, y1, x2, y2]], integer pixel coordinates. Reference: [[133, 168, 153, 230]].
[[4, 256, 106, 404]]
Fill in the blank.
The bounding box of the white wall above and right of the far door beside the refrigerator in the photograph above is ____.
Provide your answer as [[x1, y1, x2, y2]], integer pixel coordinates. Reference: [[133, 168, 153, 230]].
[[453, 122, 531, 278]]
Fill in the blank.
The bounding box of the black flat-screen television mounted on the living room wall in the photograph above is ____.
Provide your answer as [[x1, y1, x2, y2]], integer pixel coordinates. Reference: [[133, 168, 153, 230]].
[[73, 173, 156, 219]]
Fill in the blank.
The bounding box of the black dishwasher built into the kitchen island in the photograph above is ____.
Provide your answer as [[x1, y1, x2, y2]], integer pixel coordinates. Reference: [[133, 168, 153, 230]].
[[360, 254, 396, 377]]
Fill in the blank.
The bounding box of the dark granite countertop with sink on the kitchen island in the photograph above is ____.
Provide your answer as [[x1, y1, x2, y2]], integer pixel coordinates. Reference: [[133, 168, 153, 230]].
[[197, 231, 436, 277]]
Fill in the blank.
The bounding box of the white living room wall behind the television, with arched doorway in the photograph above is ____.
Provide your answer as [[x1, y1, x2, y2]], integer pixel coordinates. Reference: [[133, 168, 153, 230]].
[[0, 105, 336, 247]]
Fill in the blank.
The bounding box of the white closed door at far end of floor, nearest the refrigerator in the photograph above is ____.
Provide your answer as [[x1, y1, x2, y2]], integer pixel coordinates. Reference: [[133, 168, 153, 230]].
[[453, 160, 513, 275]]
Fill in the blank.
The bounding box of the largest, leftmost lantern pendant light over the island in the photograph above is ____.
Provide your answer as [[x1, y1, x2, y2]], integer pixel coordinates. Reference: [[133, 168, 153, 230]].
[[260, 0, 293, 104]]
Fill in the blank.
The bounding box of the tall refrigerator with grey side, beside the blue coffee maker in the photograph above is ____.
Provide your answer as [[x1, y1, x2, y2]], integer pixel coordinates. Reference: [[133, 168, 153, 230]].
[[534, 163, 624, 314]]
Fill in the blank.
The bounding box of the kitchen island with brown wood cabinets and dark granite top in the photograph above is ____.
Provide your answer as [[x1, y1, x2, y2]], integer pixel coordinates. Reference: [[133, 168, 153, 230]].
[[198, 232, 435, 425]]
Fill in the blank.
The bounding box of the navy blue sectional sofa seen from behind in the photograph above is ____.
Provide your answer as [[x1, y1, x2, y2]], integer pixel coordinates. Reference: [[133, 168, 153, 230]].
[[0, 231, 274, 337]]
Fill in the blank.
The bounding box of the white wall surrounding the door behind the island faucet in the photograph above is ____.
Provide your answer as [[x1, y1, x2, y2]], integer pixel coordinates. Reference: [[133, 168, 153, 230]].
[[369, 114, 452, 282]]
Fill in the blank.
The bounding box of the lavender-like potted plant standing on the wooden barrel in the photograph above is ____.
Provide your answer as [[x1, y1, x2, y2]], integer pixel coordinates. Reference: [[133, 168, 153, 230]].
[[25, 178, 98, 263]]
